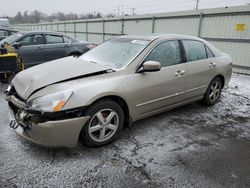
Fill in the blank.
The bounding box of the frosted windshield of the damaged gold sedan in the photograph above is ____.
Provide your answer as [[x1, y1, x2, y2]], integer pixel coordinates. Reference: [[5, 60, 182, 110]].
[[80, 38, 149, 69]]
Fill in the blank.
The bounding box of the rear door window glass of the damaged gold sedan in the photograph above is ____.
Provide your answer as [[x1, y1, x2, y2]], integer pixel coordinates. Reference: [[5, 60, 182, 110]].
[[182, 40, 207, 61]]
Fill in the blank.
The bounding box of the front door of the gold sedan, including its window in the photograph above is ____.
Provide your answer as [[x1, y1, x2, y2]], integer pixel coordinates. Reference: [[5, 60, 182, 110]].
[[134, 40, 186, 117]]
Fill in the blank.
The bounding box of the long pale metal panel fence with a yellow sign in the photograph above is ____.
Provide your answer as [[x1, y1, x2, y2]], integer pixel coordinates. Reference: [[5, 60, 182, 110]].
[[15, 6, 250, 74]]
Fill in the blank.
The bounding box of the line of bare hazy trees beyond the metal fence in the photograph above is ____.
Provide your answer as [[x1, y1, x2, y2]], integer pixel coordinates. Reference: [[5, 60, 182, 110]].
[[1, 10, 114, 24]]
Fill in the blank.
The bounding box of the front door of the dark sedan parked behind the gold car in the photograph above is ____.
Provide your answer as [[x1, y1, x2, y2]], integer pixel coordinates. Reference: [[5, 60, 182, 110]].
[[16, 34, 44, 68]]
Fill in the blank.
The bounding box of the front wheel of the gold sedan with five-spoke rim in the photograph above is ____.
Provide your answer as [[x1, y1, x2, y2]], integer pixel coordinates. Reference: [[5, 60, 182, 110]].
[[81, 100, 124, 147]]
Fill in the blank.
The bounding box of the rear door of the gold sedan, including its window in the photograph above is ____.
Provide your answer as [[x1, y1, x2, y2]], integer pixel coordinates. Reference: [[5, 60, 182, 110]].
[[182, 40, 216, 98]]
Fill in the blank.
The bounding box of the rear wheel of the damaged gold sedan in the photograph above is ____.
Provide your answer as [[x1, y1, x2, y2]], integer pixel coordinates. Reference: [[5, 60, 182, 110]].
[[202, 77, 223, 106]]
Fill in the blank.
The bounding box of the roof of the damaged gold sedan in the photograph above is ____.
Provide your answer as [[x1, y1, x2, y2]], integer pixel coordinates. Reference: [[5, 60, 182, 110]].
[[119, 33, 202, 41]]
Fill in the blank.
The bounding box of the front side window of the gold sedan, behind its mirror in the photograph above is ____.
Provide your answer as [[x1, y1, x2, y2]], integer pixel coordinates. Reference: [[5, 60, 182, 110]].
[[145, 41, 181, 67]]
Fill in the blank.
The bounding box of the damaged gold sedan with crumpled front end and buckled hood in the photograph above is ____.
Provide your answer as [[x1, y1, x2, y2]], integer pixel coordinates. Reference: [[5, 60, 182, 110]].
[[5, 34, 232, 147]]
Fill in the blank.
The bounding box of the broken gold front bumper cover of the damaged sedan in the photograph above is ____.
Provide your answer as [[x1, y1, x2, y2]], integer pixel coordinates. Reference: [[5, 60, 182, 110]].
[[9, 102, 89, 147]]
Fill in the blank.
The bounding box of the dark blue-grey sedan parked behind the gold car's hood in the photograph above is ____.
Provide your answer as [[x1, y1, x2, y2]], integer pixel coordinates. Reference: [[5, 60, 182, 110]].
[[0, 31, 95, 68]]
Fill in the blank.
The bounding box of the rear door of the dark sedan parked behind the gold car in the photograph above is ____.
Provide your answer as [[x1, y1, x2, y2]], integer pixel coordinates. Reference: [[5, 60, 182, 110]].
[[43, 34, 67, 61]]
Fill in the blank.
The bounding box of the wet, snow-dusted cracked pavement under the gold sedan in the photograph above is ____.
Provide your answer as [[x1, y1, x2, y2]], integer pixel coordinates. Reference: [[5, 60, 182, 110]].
[[0, 74, 250, 188]]
